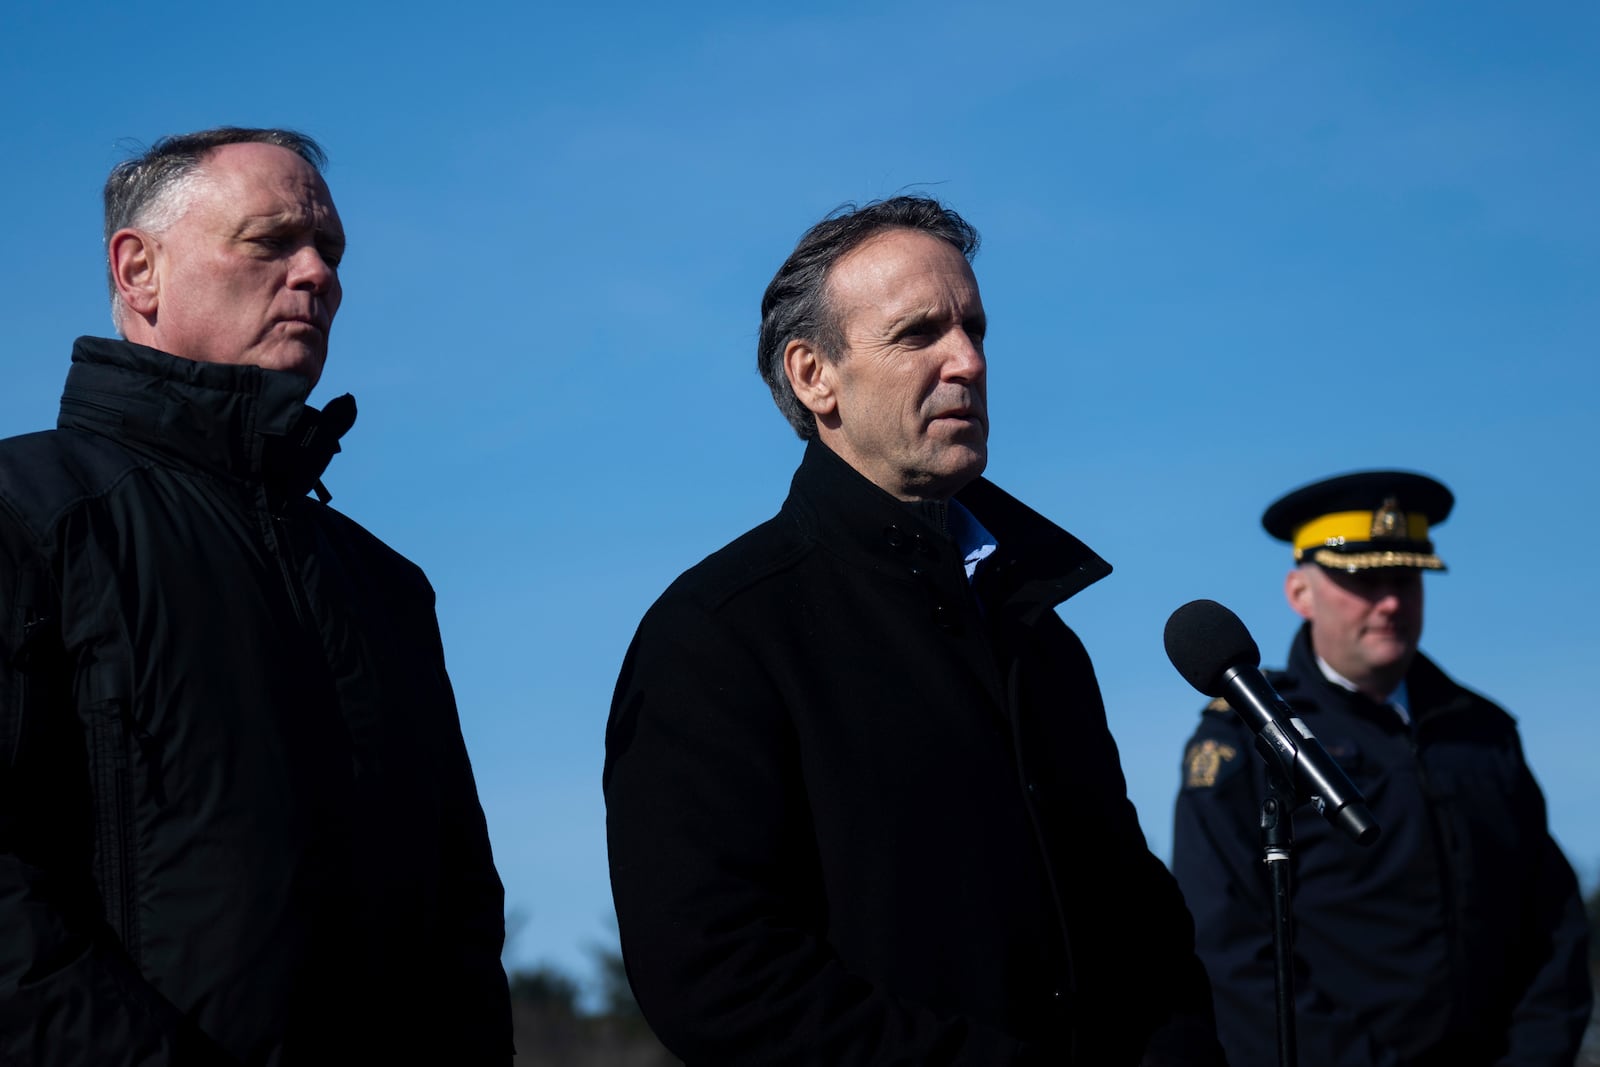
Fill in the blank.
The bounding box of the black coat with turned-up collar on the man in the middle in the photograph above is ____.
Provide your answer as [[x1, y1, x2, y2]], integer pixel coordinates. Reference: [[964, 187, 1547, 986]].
[[605, 443, 1218, 1067]]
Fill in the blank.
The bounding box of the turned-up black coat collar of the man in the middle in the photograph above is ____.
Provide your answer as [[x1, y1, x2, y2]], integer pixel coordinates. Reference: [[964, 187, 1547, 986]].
[[784, 440, 1110, 613]]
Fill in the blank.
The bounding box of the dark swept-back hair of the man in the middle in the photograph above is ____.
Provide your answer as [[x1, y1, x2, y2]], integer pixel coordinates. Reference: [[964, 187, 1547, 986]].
[[755, 197, 978, 442]]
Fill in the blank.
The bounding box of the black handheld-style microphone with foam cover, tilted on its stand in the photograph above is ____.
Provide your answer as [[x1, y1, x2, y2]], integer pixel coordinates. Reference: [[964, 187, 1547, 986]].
[[1163, 600, 1378, 845]]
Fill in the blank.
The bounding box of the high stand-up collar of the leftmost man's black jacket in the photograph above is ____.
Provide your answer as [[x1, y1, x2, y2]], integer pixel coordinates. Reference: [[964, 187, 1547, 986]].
[[56, 338, 355, 499]]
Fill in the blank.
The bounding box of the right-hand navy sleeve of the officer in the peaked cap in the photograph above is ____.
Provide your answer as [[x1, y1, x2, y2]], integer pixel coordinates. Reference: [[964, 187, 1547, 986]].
[[1499, 751, 1594, 1067]]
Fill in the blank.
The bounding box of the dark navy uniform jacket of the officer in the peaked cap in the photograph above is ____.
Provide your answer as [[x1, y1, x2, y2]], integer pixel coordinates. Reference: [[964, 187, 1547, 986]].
[[1173, 627, 1590, 1067]]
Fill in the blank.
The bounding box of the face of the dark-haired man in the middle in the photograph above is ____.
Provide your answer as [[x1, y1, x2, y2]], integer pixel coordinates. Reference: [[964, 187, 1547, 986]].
[[789, 229, 989, 501]]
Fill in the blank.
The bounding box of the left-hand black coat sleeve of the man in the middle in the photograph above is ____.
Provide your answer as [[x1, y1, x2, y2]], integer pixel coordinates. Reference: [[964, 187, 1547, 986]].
[[605, 592, 1053, 1067]]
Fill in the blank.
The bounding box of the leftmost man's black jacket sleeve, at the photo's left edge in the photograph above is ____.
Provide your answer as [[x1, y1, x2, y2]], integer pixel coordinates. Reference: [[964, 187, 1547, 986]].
[[0, 510, 235, 1067]]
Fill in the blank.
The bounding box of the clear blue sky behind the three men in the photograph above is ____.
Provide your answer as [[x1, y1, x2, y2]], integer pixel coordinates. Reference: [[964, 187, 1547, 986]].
[[0, 0, 1600, 1004]]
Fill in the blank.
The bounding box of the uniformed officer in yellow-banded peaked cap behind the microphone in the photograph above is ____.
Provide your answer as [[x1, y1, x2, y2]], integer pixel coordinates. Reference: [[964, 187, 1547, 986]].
[[1173, 470, 1590, 1067]]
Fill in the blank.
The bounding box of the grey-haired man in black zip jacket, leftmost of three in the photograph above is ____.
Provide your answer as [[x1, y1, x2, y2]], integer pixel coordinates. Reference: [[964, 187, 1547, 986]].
[[0, 128, 510, 1067]]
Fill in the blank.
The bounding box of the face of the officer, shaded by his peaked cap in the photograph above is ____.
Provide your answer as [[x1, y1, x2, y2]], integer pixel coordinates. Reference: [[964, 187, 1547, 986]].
[[1285, 563, 1422, 696]]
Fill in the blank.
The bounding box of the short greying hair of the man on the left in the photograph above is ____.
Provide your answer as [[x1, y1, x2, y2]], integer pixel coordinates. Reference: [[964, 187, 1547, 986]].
[[106, 126, 328, 331]]
